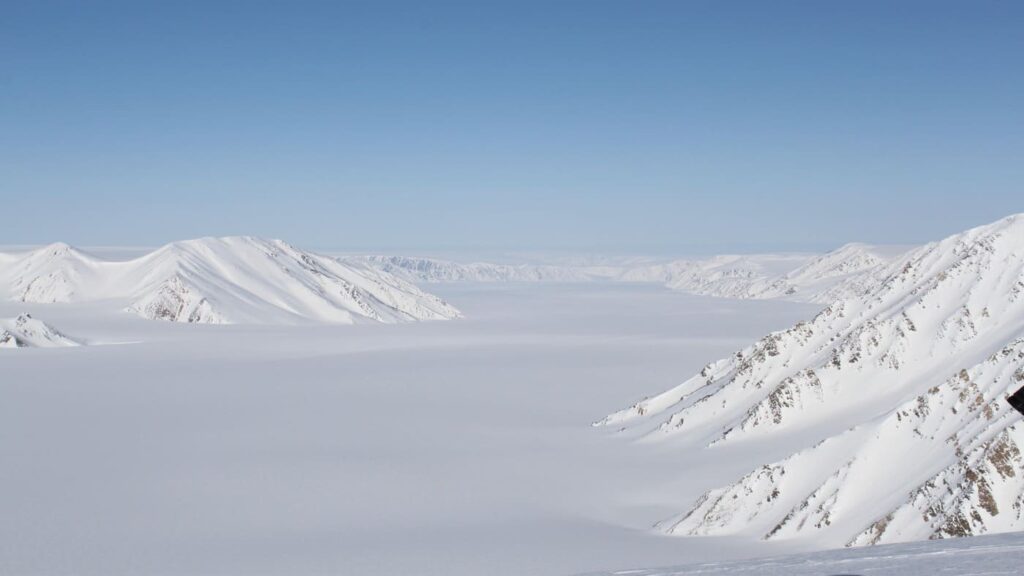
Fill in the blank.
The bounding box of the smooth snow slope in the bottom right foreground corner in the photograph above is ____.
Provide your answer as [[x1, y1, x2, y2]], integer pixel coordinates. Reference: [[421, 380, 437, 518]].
[[589, 533, 1024, 576]]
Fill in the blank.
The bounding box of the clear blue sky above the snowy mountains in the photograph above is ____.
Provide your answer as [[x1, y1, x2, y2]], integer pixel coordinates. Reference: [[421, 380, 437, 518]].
[[0, 0, 1024, 252]]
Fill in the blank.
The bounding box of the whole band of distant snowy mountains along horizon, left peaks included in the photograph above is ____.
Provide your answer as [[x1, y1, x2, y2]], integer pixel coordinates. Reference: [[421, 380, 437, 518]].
[[0, 237, 913, 324]]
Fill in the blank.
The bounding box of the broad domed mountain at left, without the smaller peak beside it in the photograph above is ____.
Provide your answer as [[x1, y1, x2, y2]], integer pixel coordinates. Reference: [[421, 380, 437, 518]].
[[123, 237, 459, 324]]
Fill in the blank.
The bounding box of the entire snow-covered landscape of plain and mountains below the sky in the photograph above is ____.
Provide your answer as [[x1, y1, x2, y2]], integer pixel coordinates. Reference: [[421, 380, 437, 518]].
[[6, 216, 1024, 576]]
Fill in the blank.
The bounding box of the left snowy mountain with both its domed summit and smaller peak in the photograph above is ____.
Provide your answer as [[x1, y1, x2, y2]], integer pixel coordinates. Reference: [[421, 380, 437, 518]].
[[0, 237, 459, 324]]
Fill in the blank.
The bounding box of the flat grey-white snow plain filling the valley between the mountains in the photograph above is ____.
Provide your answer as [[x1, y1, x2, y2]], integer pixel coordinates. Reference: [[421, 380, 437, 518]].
[[0, 276, 819, 576]]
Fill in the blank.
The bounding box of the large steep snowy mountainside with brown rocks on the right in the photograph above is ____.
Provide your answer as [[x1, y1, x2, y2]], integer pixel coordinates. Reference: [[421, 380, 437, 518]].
[[599, 215, 1024, 545]]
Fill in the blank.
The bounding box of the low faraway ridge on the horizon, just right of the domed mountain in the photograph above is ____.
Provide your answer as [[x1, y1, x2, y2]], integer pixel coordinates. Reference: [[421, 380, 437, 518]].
[[342, 256, 620, 283]]
